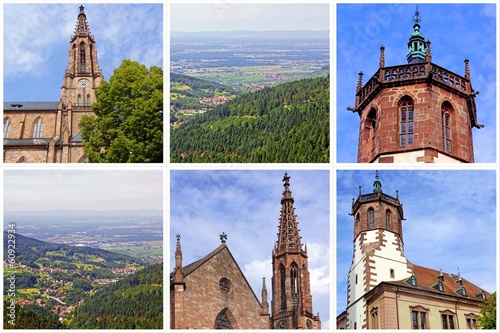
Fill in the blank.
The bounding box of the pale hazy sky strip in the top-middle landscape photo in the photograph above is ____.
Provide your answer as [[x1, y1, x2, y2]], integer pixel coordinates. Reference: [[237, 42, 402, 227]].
[[170, 1, 330, 32]]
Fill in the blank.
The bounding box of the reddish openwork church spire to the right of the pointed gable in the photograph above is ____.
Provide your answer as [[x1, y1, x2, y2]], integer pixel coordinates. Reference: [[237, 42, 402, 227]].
[[271, 173, 321, 329]]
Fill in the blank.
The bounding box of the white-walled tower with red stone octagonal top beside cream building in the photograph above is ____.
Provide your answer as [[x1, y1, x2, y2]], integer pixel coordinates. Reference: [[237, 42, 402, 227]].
[[347, 172, 412, 329]]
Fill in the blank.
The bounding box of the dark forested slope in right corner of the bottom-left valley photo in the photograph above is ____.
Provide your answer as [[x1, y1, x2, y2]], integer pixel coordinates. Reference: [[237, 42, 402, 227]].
[[70, 263, 163, 329]]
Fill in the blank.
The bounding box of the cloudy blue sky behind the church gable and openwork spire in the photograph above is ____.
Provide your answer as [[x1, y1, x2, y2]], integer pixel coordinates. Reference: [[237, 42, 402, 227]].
[[170, 170, 331, 329]]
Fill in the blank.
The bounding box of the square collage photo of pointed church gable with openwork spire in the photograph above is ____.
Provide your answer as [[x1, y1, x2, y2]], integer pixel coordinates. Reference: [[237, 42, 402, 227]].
[[169, 170, 332, 330]]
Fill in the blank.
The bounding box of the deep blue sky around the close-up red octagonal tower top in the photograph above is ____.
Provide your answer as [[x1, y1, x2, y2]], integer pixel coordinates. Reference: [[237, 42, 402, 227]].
[[335, 4, 498, 163]]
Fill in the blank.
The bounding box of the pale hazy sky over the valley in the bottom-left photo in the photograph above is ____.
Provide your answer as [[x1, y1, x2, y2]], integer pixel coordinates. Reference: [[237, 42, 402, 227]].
[[3, 168, 163, 212]]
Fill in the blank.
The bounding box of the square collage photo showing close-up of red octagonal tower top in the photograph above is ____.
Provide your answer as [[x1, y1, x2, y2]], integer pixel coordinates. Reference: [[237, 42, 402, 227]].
[[335, 3, 498, 165]]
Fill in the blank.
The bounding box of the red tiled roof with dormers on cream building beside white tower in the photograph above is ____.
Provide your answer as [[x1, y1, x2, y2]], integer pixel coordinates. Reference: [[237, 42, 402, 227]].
[[389, 265, 490, 300]]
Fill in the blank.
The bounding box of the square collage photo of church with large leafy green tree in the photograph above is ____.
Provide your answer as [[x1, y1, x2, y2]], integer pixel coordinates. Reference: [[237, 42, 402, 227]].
[[2, 3, 165, 163]]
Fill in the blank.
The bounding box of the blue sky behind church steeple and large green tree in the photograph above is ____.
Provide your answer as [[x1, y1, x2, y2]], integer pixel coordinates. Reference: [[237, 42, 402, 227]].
[[2, 2, 164, 102]]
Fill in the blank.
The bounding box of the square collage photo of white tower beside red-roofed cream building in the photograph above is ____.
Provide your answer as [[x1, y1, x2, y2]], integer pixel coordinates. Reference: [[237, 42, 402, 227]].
[[336, 169, 498, 330]]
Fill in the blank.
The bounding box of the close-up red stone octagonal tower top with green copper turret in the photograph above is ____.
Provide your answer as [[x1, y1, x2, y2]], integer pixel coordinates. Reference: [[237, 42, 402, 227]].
[[348, 7, 483, 163]]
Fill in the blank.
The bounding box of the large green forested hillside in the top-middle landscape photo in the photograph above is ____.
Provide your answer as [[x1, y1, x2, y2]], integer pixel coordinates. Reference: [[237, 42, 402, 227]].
[[170, 76, 330, 163]]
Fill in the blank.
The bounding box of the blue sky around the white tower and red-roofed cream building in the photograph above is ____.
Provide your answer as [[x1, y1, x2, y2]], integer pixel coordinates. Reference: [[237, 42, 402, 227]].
[[336, 170, 498, 314]]
